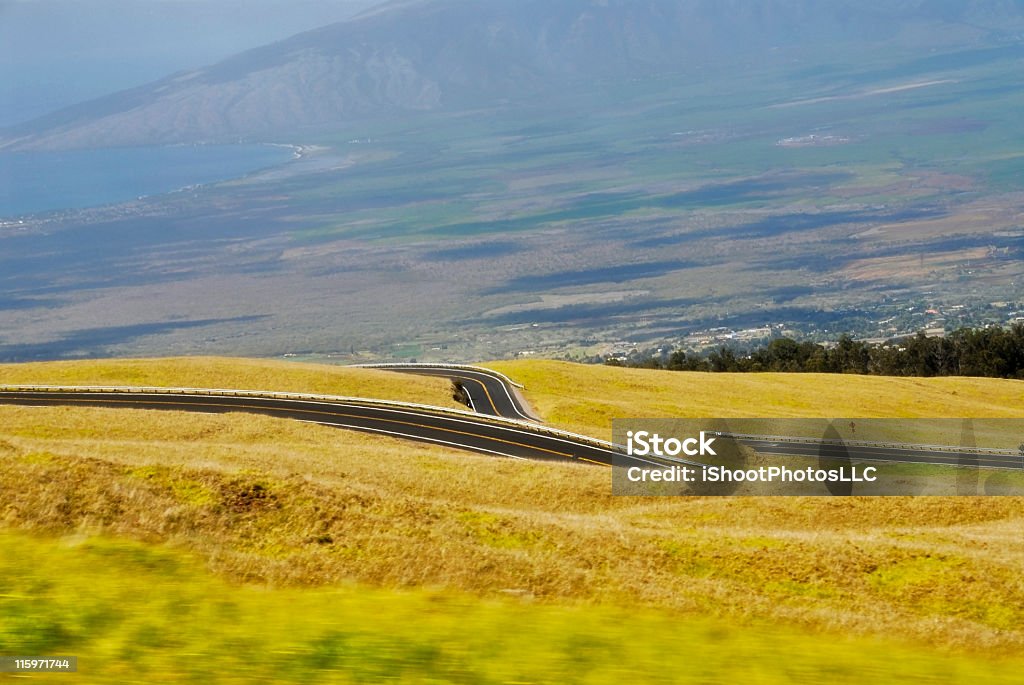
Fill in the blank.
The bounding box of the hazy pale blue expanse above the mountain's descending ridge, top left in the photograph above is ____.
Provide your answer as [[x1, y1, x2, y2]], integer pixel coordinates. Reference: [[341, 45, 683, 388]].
[[0, 0, 379, 128]]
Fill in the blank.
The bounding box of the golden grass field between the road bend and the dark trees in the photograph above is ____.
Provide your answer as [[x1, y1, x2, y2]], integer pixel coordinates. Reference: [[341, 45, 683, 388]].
[[487, 360, 1024, 438]]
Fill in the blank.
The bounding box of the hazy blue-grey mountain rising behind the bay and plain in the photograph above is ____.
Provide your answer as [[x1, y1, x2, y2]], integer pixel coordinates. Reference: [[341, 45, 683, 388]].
[[0, 0, 1024, 148]]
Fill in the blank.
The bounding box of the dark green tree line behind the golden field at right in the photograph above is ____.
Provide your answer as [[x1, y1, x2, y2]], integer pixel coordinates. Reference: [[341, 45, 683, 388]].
[[606, 324, 1024, 379]]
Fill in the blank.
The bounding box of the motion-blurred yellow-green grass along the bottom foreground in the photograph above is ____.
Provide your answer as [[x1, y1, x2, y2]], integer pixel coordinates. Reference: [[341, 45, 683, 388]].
[[0, 533, 1024, 683]]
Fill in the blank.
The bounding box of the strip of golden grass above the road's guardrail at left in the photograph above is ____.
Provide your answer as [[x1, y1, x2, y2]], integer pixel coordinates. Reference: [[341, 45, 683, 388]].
[[0, 357, 465, 409]]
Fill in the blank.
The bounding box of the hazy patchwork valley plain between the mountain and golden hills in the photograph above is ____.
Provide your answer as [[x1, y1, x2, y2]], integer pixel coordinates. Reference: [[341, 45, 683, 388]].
[[8, 44, 1024, 360]]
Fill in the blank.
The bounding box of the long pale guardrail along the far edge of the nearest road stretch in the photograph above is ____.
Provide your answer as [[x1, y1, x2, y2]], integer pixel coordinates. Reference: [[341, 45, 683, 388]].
[[0, 385, 621, 452]]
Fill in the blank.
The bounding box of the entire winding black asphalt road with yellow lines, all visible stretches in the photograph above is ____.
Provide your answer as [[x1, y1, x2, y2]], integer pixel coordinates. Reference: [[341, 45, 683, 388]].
[[0, 365, 1024, 469]]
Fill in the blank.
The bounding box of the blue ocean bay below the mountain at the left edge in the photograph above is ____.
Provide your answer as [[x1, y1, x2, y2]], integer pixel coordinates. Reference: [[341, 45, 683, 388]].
[[0, 145, 293, 218]]
